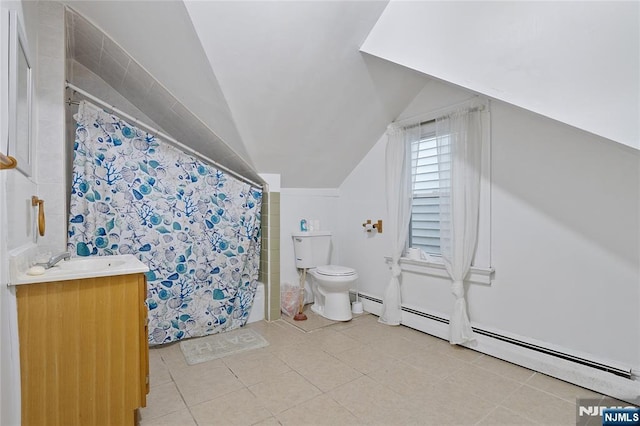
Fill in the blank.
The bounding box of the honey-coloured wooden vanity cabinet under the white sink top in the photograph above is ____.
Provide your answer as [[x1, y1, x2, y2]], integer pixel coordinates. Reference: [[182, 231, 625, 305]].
[[16, 273, 149, 426]]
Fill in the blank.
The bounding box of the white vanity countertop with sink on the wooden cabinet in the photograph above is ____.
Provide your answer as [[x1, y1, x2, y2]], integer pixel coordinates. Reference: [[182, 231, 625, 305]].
[[9, 254, 149, 285]]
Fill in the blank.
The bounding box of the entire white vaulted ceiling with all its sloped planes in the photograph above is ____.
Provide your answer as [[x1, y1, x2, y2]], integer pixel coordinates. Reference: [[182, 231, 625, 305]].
[[64, 0, 640, 188]]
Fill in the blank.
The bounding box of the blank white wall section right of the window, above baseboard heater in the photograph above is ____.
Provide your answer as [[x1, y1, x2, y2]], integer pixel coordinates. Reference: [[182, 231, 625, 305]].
[[484, 103, 640, 368]]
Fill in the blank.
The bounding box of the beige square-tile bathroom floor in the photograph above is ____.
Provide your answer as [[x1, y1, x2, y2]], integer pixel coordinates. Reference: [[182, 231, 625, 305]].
[[141, 313, 601, 426]]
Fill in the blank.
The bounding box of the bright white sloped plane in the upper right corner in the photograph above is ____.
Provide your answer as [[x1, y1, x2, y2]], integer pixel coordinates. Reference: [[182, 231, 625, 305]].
[[361, 1, 640, 148]]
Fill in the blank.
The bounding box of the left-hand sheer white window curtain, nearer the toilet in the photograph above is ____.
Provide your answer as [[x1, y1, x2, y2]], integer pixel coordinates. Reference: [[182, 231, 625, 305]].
[[378, 125, 420, 325]]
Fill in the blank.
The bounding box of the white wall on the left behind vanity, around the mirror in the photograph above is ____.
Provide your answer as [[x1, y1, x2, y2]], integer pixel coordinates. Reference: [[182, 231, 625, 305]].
[[0, 1, 66, 425]]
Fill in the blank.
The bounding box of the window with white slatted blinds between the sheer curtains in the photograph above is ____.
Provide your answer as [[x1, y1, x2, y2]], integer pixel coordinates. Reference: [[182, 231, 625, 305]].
[[409, 121, 450, 255]]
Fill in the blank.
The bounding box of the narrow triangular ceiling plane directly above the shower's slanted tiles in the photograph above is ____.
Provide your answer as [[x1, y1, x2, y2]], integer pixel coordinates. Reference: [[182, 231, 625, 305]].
[[65, 0, 255, 168]]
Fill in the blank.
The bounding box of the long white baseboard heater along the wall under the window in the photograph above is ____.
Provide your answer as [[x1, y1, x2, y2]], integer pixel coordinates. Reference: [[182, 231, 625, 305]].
[[359, 293, 640, 404]]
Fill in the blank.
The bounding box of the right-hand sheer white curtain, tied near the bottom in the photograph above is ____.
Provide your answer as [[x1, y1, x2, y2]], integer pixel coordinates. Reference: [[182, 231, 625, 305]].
[[436, 108, 482, 344]]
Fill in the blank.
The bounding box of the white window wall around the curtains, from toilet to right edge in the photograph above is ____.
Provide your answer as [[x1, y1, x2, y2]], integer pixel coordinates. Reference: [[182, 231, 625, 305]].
[[337, 81, 640, 374]]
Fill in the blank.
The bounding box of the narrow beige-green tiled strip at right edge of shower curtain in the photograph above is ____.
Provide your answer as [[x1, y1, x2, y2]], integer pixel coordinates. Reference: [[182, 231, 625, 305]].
[[259, 191, 280, 321]]
